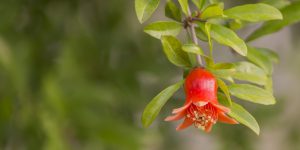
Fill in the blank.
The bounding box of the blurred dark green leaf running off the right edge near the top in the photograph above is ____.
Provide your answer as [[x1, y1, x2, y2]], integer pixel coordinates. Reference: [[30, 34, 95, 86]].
[[247, 2, 300, 41]]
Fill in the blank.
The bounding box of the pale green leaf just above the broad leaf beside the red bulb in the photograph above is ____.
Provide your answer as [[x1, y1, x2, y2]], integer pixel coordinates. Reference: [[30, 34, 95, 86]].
[[232, 61, 267, 85]]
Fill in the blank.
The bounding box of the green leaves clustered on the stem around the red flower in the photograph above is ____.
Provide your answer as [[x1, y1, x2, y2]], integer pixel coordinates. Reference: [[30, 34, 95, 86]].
[[135, 0, 299, 134]]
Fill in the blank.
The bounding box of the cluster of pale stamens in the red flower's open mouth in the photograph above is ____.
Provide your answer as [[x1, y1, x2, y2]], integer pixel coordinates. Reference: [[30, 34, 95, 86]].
[[186, 103, 218, 130]]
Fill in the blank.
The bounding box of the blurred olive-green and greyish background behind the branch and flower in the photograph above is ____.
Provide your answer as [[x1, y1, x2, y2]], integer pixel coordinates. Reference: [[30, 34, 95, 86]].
[[0, 0, 300, 150]]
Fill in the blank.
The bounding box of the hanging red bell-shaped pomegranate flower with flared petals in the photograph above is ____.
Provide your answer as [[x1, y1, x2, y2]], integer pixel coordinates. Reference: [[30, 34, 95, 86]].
[[165, 68, 238, 132]]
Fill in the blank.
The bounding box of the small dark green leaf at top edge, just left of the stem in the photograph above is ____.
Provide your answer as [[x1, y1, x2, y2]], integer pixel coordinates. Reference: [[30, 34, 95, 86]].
[[165, 0, 181, 22]]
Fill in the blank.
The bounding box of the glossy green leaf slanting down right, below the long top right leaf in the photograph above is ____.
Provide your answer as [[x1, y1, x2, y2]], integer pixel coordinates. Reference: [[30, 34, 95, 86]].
[[210, 24, 247, 56]]
